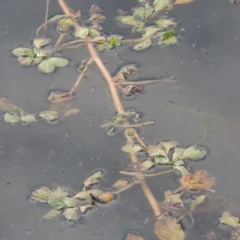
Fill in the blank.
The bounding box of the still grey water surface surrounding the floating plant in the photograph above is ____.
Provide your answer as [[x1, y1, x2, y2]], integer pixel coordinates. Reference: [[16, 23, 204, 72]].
[[0, 0, 240, 240]]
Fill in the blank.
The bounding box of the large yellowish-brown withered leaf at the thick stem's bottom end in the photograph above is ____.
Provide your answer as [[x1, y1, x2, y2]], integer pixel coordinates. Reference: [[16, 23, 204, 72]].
[[154, 217, 185, 240]]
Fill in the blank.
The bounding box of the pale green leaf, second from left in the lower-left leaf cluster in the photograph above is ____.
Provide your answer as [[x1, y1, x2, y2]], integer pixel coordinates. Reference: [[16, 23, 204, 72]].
[[47, 187, 68, 209]]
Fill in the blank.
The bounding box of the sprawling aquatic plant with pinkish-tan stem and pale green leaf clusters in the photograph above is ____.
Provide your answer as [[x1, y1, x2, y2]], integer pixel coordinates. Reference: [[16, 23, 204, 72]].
[[6, 0, 240, 240]]
